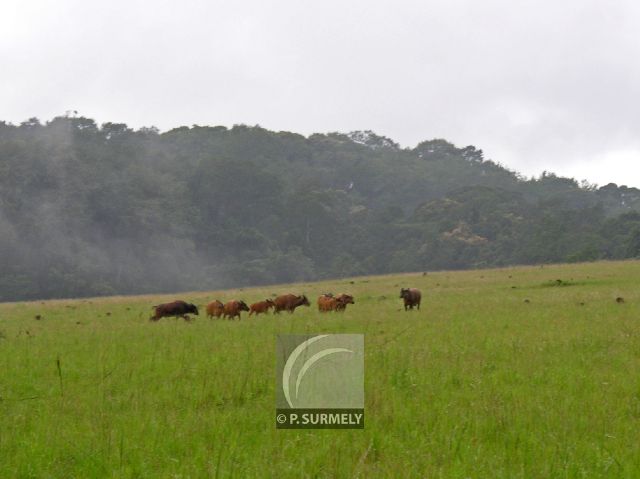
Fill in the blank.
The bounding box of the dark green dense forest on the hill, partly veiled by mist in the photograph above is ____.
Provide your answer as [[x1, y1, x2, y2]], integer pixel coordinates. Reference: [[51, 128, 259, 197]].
[[0, 116, 640, 301]]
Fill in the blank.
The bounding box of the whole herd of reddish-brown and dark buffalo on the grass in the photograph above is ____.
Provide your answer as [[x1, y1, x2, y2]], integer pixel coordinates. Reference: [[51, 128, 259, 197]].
[[150, 288, 422, 321]]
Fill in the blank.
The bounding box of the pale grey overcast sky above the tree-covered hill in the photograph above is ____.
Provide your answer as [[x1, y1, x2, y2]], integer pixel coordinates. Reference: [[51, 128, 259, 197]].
[[0, 0, 640, 187]]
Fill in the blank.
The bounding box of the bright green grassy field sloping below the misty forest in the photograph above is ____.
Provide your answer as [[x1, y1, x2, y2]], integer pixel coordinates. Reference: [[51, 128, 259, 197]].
[[0, 262, 640, 478]]
